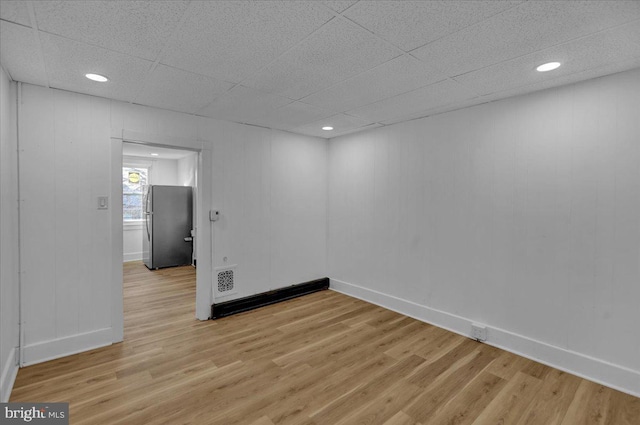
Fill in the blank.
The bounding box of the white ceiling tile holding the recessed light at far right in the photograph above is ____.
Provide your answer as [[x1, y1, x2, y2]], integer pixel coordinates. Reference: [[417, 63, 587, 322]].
[[455, 24, 640, 95]]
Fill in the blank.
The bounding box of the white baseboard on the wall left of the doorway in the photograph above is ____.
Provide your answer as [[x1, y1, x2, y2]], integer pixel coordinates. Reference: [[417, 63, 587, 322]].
[[23, 328, 113, 366]]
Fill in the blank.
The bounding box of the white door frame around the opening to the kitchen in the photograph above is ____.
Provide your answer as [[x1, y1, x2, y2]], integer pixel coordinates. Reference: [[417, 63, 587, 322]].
[[110, 130, 213, 342]]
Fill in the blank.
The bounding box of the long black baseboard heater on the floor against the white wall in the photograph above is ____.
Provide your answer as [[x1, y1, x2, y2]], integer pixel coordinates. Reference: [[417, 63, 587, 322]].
[[211, 277, 329, 320]]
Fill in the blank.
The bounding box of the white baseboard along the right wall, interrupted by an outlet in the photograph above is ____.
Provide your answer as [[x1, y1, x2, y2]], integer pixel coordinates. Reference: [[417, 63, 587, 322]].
[[330, 279, 640, 397]]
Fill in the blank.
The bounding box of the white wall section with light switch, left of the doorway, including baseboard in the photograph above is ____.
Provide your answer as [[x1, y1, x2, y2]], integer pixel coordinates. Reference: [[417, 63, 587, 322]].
[[19, 84, 115, 364]]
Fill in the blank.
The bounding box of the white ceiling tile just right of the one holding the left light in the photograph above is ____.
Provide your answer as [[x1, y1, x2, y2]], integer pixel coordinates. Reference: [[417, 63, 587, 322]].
[[134, 65, 233, 113]]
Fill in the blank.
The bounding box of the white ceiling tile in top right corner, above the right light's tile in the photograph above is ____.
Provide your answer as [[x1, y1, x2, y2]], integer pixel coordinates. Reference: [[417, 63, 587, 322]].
[[412, 1, 640, 77]]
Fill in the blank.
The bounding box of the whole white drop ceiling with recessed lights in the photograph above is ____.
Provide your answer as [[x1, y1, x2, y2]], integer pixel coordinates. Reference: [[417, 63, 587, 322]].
[[0, 0, 640, 137]]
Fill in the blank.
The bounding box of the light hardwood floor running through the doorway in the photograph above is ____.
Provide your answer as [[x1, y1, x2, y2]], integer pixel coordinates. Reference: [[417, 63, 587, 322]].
[[11, 263, 640, 425]]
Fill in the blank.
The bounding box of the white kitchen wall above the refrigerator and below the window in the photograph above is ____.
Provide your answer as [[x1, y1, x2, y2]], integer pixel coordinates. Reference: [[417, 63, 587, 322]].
[[122, 154, 184, 261]]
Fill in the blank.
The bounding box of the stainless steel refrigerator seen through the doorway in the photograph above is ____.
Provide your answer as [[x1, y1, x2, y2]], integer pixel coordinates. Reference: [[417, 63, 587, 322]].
[[142, 185, 193, 269]]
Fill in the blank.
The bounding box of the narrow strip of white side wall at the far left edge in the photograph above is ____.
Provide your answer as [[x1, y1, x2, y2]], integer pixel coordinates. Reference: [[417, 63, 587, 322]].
[[0, 67, 19, 402]]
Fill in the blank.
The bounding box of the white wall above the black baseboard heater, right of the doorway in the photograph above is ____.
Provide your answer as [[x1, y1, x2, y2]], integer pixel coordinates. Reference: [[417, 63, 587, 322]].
[[210, 120, 327, 300]]
